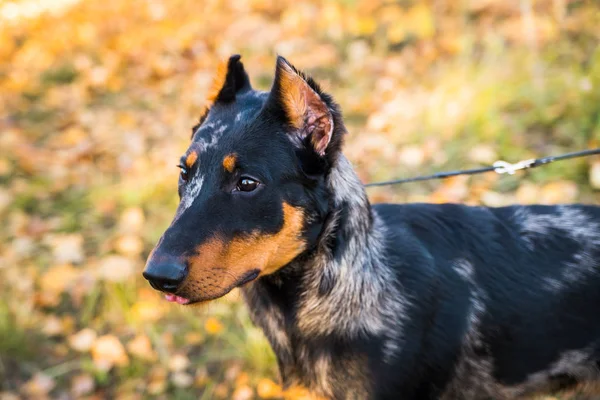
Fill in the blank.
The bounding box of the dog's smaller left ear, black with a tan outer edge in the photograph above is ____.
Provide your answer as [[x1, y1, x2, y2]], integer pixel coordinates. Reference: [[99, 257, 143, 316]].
[[208, 54, 251, 106]]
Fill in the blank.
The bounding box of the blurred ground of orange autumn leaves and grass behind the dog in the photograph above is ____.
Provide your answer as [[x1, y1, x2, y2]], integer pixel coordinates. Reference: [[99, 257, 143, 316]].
[[0, 0, 600, 400]]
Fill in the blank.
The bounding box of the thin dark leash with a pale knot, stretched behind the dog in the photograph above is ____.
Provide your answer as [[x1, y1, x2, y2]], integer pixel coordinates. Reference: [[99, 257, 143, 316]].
[[365, 148, 600, 187]]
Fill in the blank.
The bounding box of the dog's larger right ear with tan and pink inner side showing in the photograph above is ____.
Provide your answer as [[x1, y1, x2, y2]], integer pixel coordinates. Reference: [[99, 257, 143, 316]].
[[267, 56, 334, 156]]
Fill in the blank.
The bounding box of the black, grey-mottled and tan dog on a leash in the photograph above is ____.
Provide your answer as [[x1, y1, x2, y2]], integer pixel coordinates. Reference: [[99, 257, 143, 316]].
[[143, 55, 600, 400]]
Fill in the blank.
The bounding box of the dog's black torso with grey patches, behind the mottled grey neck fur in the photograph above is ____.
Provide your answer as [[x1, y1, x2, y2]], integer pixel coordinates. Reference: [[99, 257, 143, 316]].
[[374, 204, 600, 399]]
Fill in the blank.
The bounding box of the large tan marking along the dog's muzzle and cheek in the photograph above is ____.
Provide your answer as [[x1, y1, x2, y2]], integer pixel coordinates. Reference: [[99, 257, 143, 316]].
[[182, 203, 306, 298]]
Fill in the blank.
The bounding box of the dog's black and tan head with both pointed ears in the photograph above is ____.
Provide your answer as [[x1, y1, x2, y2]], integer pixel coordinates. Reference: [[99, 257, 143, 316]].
[[144, 55, 345, 304]]
